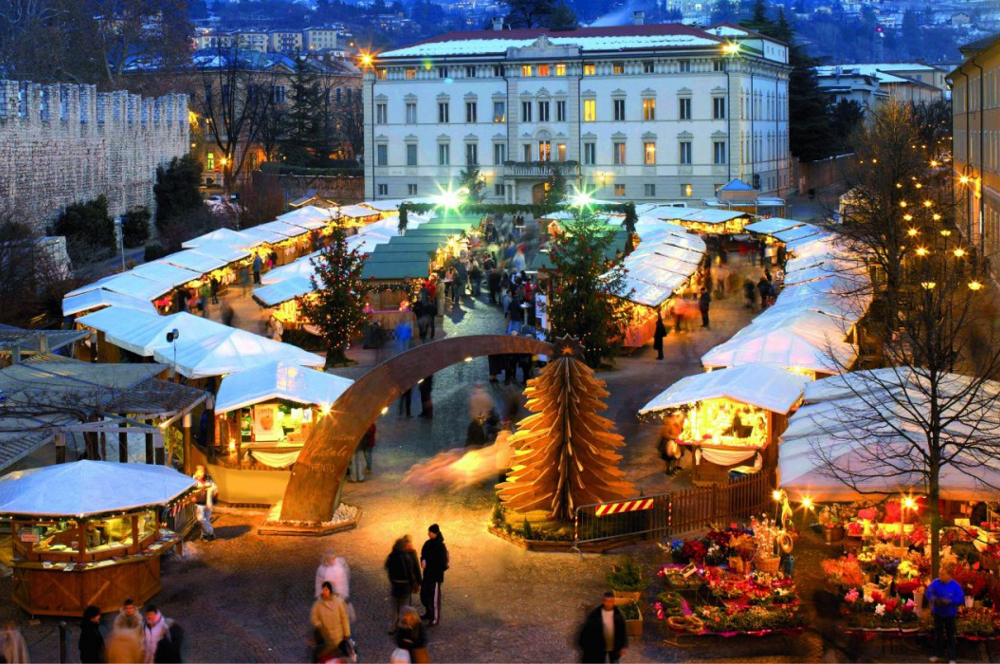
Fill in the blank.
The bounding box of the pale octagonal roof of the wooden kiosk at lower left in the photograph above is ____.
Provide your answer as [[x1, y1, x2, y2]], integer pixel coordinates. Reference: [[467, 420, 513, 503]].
[[0, 460, 195, 517]]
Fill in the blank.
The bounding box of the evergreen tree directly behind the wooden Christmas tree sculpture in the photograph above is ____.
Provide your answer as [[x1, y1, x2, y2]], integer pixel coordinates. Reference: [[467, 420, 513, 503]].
[[548, 213, 629, 368]]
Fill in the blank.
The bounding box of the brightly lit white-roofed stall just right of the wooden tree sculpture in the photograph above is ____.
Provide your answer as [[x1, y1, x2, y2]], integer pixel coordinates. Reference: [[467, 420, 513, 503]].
[[639, 364, 807, 485]]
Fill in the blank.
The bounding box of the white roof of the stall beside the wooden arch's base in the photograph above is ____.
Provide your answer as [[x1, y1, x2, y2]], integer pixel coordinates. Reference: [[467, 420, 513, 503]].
[[215, 362, 354, 415]]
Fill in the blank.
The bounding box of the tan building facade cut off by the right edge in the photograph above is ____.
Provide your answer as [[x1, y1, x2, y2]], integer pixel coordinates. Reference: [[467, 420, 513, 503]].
[[948, 35, 1000, 268]]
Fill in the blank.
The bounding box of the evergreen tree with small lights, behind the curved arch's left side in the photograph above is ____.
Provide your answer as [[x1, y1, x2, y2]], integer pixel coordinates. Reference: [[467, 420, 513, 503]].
[[299, 228, 365, 368]]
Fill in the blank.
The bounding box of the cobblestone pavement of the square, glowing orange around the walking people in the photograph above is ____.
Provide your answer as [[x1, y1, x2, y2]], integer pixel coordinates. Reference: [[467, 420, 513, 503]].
[[0, 253, 928, 662]]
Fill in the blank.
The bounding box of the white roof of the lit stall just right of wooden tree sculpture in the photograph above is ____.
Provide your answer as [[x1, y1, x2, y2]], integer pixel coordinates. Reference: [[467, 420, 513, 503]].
[[639, 363, 809, 415]]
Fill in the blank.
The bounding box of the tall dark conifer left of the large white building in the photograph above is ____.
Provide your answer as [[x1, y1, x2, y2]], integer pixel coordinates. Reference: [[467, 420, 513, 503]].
[[281, 57, 329, 166]]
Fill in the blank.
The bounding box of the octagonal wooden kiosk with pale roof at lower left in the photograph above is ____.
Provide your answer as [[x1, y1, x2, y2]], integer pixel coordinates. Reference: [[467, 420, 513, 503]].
[[0, 461, 195, 616]]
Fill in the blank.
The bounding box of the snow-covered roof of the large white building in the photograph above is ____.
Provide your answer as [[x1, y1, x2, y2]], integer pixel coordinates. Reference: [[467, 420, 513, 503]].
[[379, 23, 722, 59]]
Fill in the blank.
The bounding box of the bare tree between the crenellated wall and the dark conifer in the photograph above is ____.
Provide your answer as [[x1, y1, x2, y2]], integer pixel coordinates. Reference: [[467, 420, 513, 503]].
[[195, 45, 281, 192]]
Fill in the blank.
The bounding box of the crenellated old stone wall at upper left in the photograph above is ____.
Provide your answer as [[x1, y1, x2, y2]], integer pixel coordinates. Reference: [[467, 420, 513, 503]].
[[0, 80, 190, 231]]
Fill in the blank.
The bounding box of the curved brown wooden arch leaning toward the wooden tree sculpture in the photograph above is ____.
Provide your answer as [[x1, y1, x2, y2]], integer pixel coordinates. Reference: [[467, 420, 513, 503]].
[[281, 335, 552, 523]]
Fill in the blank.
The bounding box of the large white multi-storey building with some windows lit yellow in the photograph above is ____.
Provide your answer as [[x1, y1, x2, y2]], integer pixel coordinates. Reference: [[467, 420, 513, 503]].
[[364, 20, 791, 202]]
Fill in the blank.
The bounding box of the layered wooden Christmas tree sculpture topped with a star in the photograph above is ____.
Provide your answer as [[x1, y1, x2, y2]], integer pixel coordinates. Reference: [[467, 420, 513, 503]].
[[497, 338, 635, 521]]
